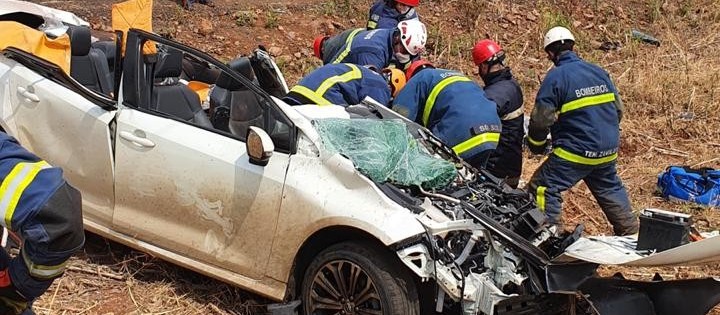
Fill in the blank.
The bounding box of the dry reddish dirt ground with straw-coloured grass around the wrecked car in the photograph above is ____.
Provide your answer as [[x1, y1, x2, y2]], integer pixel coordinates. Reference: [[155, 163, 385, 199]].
[[22, 0, 720, 314]]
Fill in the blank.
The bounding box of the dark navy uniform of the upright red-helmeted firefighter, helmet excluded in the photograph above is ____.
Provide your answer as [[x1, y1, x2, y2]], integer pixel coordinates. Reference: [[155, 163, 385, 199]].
[[485, 68, 525, 188]]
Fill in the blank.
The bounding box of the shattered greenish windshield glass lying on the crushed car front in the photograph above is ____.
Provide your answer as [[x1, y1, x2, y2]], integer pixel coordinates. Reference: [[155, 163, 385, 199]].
[[314, 118, 457, 189]]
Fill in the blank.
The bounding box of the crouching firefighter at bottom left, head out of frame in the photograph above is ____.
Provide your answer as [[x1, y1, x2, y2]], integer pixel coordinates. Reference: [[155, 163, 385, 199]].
[[0, 132, 85, 314]]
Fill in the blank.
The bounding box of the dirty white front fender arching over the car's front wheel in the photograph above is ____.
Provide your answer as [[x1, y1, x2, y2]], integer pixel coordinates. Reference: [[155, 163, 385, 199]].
[[268, 99, 434, 281]]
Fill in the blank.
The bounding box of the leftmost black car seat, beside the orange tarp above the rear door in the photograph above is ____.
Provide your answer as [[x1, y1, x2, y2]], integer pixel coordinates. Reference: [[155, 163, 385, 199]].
[[67, 25, 113, 95]]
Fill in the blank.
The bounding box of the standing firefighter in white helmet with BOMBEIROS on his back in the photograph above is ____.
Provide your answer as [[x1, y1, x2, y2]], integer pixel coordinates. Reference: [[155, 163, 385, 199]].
[[527, 27, 638, 235]]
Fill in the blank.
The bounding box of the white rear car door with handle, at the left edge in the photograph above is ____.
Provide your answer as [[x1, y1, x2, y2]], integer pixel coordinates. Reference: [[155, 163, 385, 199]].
[[0, 48, 116, 226]]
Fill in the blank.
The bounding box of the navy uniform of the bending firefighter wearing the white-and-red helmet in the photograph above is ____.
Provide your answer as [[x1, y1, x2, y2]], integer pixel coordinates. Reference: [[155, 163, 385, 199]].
[[323, 28, 396, 70]]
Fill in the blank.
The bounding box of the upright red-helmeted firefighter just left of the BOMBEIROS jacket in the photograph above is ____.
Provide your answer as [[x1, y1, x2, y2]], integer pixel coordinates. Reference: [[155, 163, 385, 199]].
[[472, 39, 525, 188]]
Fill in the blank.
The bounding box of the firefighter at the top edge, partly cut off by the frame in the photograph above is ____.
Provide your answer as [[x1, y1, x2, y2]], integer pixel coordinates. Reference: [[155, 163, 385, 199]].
[[367, 0, 420, 30]]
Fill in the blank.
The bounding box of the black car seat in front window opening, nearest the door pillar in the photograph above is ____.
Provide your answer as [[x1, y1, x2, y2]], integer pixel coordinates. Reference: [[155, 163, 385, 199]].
[[149, 47, 212, 128]]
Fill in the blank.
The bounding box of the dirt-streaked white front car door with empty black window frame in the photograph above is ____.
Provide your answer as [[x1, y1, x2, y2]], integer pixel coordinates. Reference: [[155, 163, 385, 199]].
[[113, 31, 290, 279]]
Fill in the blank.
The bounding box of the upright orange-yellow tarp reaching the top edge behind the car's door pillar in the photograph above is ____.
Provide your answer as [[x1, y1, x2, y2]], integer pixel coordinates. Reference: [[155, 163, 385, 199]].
[[112, 0, 157, 56]]
